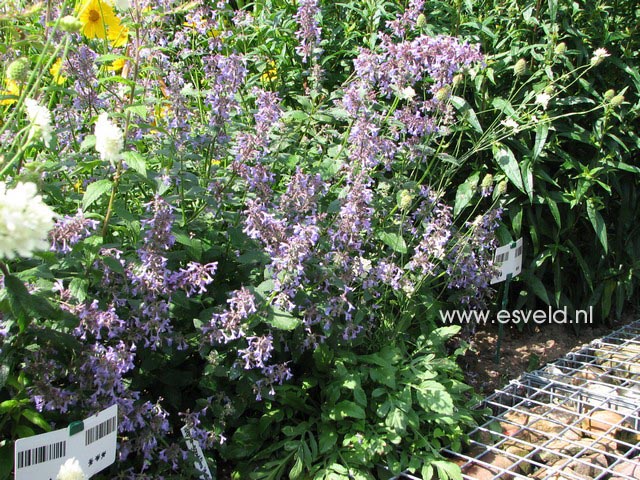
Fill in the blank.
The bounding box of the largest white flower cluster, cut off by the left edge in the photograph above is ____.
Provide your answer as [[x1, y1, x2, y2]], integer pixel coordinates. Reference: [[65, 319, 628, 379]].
[[0, 182, 56, 260]]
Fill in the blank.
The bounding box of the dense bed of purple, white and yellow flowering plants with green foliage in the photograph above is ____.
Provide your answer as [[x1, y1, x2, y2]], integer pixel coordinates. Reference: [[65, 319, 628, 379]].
[[0, 0, 640, 479]]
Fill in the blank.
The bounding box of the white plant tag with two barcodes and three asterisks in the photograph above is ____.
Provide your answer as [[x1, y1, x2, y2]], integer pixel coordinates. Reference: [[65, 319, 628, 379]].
[[14, 405, 118, 480]]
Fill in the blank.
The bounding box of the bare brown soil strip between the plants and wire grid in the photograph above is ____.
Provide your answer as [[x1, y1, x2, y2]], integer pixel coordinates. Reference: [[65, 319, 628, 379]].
[[461, 312, 638, 395]]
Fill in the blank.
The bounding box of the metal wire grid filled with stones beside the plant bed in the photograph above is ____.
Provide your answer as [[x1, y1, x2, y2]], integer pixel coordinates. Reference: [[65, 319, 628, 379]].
[[398, 320, 640, 480]]
